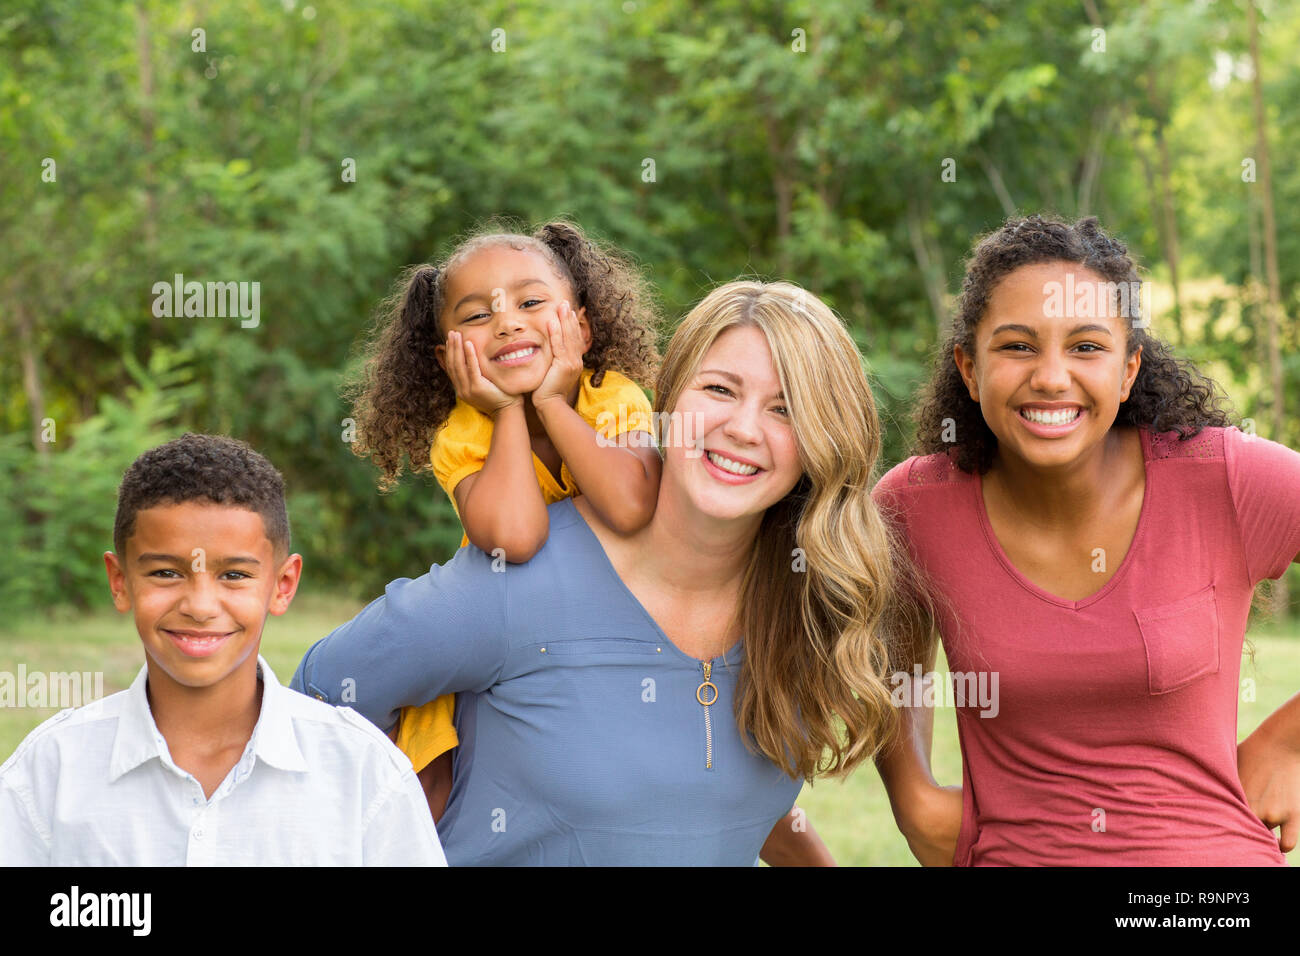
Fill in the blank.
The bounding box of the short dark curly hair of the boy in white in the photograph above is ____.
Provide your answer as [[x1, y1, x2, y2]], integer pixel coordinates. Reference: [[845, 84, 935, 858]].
[[113, 433, 289, 558]]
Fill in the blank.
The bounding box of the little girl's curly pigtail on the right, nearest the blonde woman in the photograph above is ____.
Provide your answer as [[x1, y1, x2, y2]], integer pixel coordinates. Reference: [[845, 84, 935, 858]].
[[533, 220, 659, 386]]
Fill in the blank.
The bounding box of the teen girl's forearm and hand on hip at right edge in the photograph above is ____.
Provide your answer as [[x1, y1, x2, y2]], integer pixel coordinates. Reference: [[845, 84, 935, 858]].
[[1236, 693, 1300, 853]]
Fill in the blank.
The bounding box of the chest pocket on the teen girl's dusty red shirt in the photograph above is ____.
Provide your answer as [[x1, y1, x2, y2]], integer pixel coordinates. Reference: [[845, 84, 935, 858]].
[[1134, 584, 1219, 693]]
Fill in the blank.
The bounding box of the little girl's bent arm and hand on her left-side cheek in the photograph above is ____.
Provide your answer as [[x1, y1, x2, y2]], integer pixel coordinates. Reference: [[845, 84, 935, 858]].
[[447, 332, 550, 563]]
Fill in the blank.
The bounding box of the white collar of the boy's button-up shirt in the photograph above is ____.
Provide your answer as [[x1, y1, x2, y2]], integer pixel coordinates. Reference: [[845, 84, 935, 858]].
[[108, 654, 308, 783]]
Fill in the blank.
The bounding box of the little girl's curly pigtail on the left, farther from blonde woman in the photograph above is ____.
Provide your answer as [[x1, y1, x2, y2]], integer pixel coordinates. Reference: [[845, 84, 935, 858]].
[[347, 265, 456, 490]]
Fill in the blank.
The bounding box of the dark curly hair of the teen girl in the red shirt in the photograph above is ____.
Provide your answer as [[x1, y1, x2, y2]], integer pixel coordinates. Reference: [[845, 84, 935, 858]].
[[917, 216, 1231, 475]]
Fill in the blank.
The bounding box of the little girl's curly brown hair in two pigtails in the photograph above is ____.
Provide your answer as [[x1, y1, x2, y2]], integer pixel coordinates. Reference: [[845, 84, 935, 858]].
[[345, 220, 659, 490]]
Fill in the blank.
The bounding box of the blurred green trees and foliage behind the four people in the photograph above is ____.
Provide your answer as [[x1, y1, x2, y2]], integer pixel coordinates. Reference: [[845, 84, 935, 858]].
[[0, 0, 1300, 613]]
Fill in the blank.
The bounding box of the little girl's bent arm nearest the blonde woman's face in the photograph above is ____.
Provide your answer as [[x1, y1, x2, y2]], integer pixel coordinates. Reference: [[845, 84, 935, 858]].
[[533, 307, 662, 535]]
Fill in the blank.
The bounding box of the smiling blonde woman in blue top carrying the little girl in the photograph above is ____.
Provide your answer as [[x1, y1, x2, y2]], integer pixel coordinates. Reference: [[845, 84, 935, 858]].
[[294, 282, 915, 865]]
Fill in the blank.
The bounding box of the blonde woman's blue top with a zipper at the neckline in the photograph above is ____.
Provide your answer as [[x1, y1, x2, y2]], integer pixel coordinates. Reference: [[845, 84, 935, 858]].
[[293, 498, 802, 866]]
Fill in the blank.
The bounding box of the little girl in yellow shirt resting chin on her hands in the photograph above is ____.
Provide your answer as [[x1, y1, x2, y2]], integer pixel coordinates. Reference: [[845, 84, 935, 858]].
[[354, 221, 660, 819]]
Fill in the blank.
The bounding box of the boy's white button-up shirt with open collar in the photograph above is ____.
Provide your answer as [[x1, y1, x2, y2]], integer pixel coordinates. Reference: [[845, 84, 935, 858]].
[[0, 657, 447, 866]]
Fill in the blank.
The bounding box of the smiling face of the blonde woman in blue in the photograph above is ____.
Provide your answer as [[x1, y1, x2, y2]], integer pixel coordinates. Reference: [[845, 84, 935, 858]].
[[664, 325, 803, 519]]
